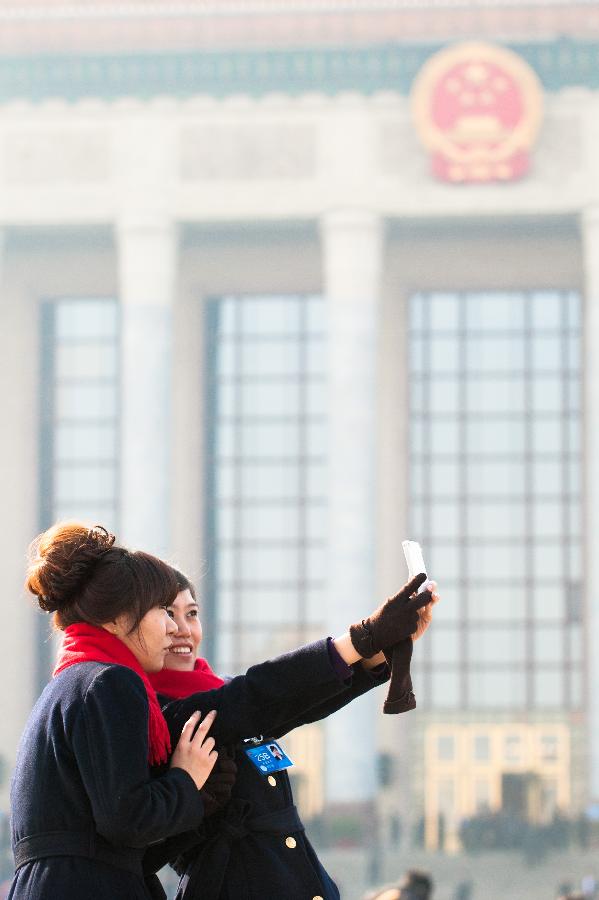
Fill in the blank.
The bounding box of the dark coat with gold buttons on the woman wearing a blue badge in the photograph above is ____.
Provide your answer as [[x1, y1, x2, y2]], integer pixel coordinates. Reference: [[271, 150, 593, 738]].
[[156, 640, 389, 900]]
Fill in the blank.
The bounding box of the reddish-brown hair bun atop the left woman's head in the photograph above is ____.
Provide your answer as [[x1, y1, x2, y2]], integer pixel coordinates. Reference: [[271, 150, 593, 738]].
[[25, 522, 115, 612]]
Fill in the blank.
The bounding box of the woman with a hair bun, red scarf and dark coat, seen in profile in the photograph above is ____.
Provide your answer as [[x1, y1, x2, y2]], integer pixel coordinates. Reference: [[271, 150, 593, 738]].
[[8, 523, 217, 900]]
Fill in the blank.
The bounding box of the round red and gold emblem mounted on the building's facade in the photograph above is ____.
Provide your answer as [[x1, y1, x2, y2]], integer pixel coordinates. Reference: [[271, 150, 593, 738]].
[[412, 43, 543, 182]]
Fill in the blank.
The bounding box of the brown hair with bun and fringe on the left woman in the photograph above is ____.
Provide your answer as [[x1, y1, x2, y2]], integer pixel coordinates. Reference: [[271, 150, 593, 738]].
[[25, 522, 178, 631]]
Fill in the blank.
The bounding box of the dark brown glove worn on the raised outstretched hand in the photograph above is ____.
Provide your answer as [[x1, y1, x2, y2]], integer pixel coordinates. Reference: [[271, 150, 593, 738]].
[[349, 573, 432, 659]]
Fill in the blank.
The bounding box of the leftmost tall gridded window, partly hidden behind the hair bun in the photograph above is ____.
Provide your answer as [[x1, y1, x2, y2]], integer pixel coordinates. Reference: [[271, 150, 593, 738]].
[[37, 298, 119, 688]]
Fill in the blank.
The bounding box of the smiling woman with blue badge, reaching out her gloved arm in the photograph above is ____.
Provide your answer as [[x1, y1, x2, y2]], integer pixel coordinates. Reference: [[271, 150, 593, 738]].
[[151, 571, 438, 900]]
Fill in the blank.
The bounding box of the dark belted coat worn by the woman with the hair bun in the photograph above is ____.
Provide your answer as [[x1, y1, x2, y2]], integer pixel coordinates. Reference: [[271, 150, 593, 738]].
[[8, 662, 204, 900]]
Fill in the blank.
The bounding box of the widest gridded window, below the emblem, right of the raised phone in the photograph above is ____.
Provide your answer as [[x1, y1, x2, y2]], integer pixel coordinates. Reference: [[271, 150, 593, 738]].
[[409, 290, 583, 709]]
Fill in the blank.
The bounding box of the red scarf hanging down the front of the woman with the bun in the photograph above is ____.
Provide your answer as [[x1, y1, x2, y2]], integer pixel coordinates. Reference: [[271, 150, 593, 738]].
[[52, 622, 171, 766]]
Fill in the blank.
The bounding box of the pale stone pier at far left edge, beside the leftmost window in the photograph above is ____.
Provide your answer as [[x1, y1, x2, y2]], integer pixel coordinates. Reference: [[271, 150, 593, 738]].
[[0, 230, 39, 810]]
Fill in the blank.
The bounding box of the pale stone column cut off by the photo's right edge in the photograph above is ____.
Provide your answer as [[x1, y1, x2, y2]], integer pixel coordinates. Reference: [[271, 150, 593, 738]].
[[581, 203, 599, 802]]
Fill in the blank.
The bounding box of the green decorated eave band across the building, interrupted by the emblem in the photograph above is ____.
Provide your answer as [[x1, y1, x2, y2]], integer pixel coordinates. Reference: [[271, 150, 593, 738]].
[[0, 38, 599, 101]]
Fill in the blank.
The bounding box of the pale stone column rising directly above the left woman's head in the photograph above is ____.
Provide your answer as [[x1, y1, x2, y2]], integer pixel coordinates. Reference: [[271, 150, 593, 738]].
[[117, 219, 176, 555]]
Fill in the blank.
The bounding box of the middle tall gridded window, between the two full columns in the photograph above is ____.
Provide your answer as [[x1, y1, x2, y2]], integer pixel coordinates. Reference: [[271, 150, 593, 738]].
[[203, 295, 326, 672]]
